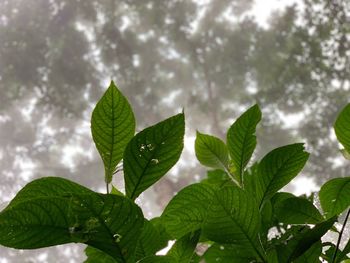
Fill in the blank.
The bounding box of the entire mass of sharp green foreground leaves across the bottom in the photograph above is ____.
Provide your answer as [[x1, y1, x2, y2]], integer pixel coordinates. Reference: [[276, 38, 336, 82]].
[[0, 82, 350, 263]]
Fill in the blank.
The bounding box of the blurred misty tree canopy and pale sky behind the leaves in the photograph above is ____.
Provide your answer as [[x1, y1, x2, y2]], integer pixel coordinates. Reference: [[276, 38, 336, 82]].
[[0, 0, 350, 263]]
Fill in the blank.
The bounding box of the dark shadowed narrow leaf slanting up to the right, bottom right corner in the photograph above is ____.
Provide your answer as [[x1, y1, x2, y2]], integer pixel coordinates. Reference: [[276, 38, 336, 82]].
[[277, 217, 336, 262]]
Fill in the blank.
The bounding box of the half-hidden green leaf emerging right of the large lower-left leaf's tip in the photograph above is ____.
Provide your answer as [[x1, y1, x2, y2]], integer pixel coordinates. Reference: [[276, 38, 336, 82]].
[[136, 219, 163, 260]]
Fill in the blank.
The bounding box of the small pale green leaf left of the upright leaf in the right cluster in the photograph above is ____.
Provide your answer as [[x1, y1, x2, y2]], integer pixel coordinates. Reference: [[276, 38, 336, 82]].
[[195, 131, 229, 170]]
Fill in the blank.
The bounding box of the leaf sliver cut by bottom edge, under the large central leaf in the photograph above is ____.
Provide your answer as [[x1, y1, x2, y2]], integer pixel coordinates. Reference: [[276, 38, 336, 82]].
[[203, 243, 255, 263]]
